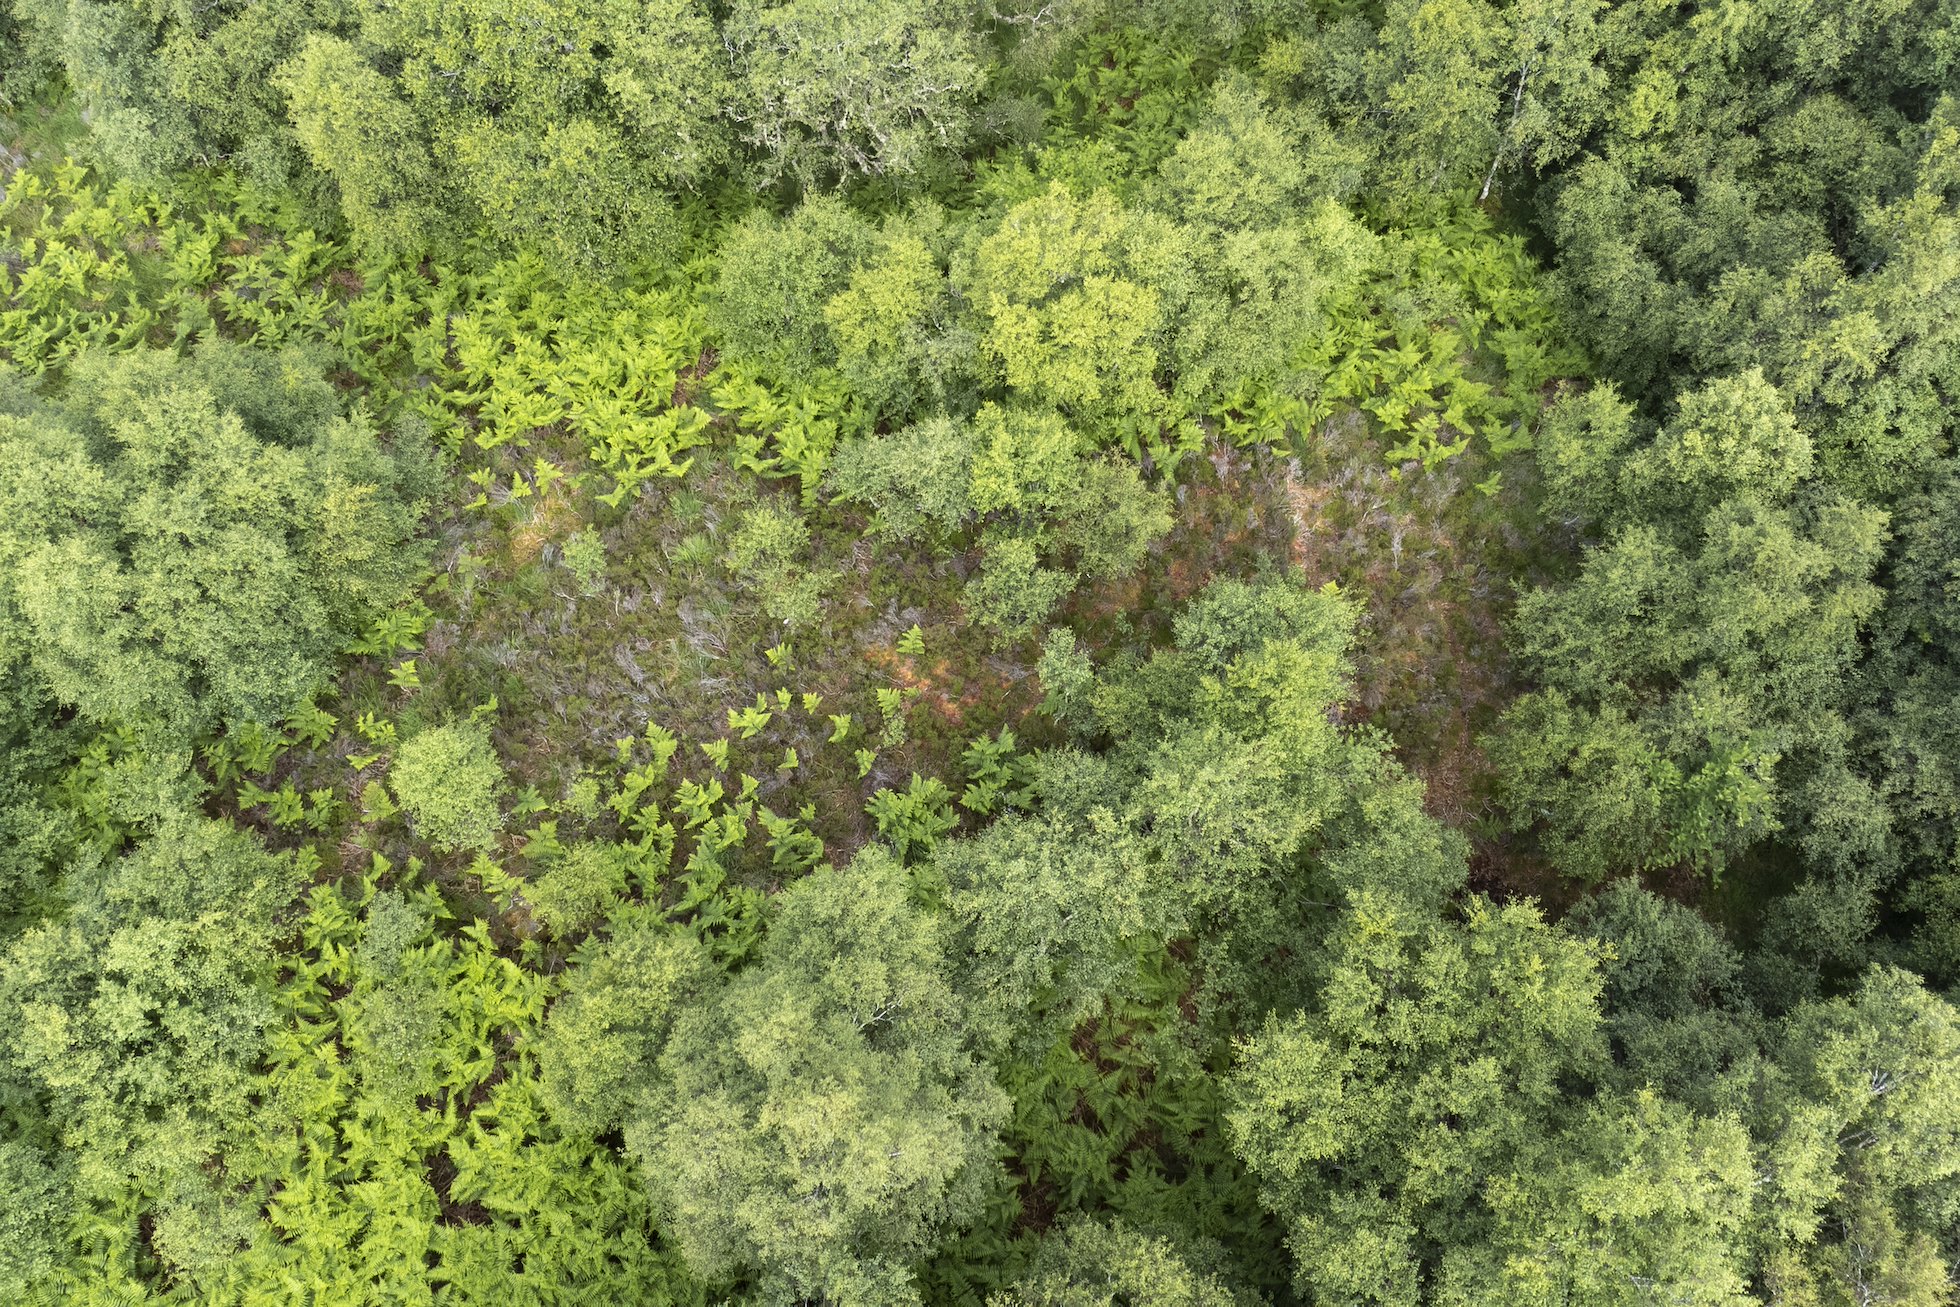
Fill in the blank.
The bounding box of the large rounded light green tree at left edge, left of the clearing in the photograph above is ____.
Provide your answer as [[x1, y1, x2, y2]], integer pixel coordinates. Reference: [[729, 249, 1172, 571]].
[[0, 353, 429, 739]]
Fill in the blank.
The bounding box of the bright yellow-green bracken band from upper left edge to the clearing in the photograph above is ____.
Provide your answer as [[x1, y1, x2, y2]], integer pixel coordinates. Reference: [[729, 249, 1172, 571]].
[[0, 154, 708, 502]]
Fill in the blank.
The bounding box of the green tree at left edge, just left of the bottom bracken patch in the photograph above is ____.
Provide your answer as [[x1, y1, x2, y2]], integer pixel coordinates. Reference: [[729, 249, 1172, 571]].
[[0, 815, 298, 1272]]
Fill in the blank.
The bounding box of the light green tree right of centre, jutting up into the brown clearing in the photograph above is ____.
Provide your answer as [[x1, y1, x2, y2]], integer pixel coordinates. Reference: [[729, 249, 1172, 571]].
[[1084, 578, 1466, 1021]]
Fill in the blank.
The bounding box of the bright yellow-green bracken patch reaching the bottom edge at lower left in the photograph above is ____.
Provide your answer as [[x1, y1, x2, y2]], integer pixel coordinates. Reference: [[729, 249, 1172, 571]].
[[196, 880, 694, 1303]]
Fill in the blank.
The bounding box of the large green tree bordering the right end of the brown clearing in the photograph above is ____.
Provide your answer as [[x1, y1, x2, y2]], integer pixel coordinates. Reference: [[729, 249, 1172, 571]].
[[1492, 372, 1886, 880]]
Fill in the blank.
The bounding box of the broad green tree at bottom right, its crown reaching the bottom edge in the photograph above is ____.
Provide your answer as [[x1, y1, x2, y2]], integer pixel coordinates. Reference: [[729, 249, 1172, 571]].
[[1229, 894, 1605, 1305]]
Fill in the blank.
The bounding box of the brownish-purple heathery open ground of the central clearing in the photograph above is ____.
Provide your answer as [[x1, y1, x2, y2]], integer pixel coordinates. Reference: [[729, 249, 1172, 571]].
[[286, 403, 1556, 924]]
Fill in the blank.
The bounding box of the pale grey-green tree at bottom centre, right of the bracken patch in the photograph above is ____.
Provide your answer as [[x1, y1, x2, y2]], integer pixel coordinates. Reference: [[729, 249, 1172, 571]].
[[627, 848, 1007, 1303]]
